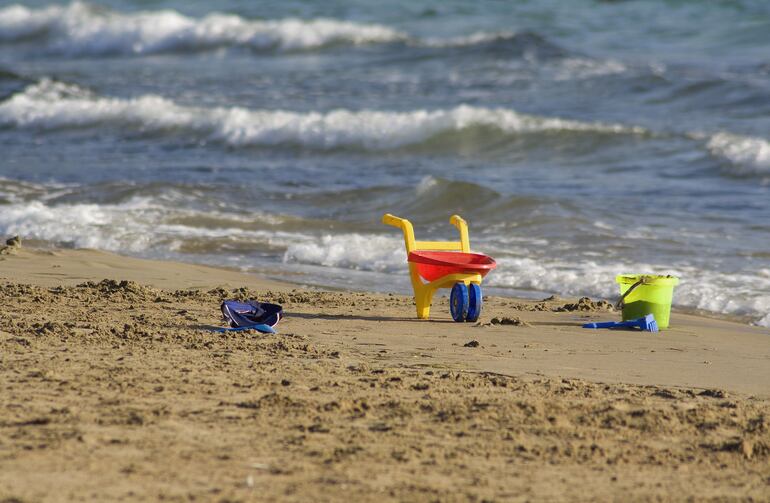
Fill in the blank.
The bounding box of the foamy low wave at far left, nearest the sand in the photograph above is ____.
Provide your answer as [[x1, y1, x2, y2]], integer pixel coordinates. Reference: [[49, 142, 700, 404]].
[[0, 195, 312, 255]]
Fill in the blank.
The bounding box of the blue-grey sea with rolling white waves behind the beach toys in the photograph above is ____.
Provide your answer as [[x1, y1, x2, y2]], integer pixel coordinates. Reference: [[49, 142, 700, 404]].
[[0, 0, 770, 327]]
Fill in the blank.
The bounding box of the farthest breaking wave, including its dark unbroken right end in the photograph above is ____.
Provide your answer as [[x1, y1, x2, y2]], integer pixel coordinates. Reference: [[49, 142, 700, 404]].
[[0, 1, 584, 58]]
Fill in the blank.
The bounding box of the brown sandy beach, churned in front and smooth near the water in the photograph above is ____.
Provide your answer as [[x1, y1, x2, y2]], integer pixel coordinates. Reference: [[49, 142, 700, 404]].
[[0, 248, 770, 502]]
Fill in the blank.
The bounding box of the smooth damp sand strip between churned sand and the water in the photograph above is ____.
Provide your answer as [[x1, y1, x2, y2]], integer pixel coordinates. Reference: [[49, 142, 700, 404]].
[[0, 248, 770, 397]]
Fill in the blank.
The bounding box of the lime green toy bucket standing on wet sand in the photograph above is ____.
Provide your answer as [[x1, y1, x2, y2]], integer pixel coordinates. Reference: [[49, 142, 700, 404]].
[[615, 274, 679, 329]]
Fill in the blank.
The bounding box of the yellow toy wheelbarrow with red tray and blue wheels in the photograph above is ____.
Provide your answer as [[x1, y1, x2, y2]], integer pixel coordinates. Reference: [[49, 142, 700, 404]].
[[382, 213, 497, 321]]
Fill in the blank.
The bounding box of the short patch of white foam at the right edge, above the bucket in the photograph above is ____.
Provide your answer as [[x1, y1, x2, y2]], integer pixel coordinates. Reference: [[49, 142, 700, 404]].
[[706, 133, 770, 175]]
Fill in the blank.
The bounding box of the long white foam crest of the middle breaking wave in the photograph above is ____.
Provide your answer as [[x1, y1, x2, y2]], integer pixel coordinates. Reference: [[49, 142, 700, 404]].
[[0, 79, 645, 150]]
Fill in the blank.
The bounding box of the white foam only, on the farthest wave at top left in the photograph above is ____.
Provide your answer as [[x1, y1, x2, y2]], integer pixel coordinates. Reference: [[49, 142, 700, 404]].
[[0, 2, 405, 55]]
